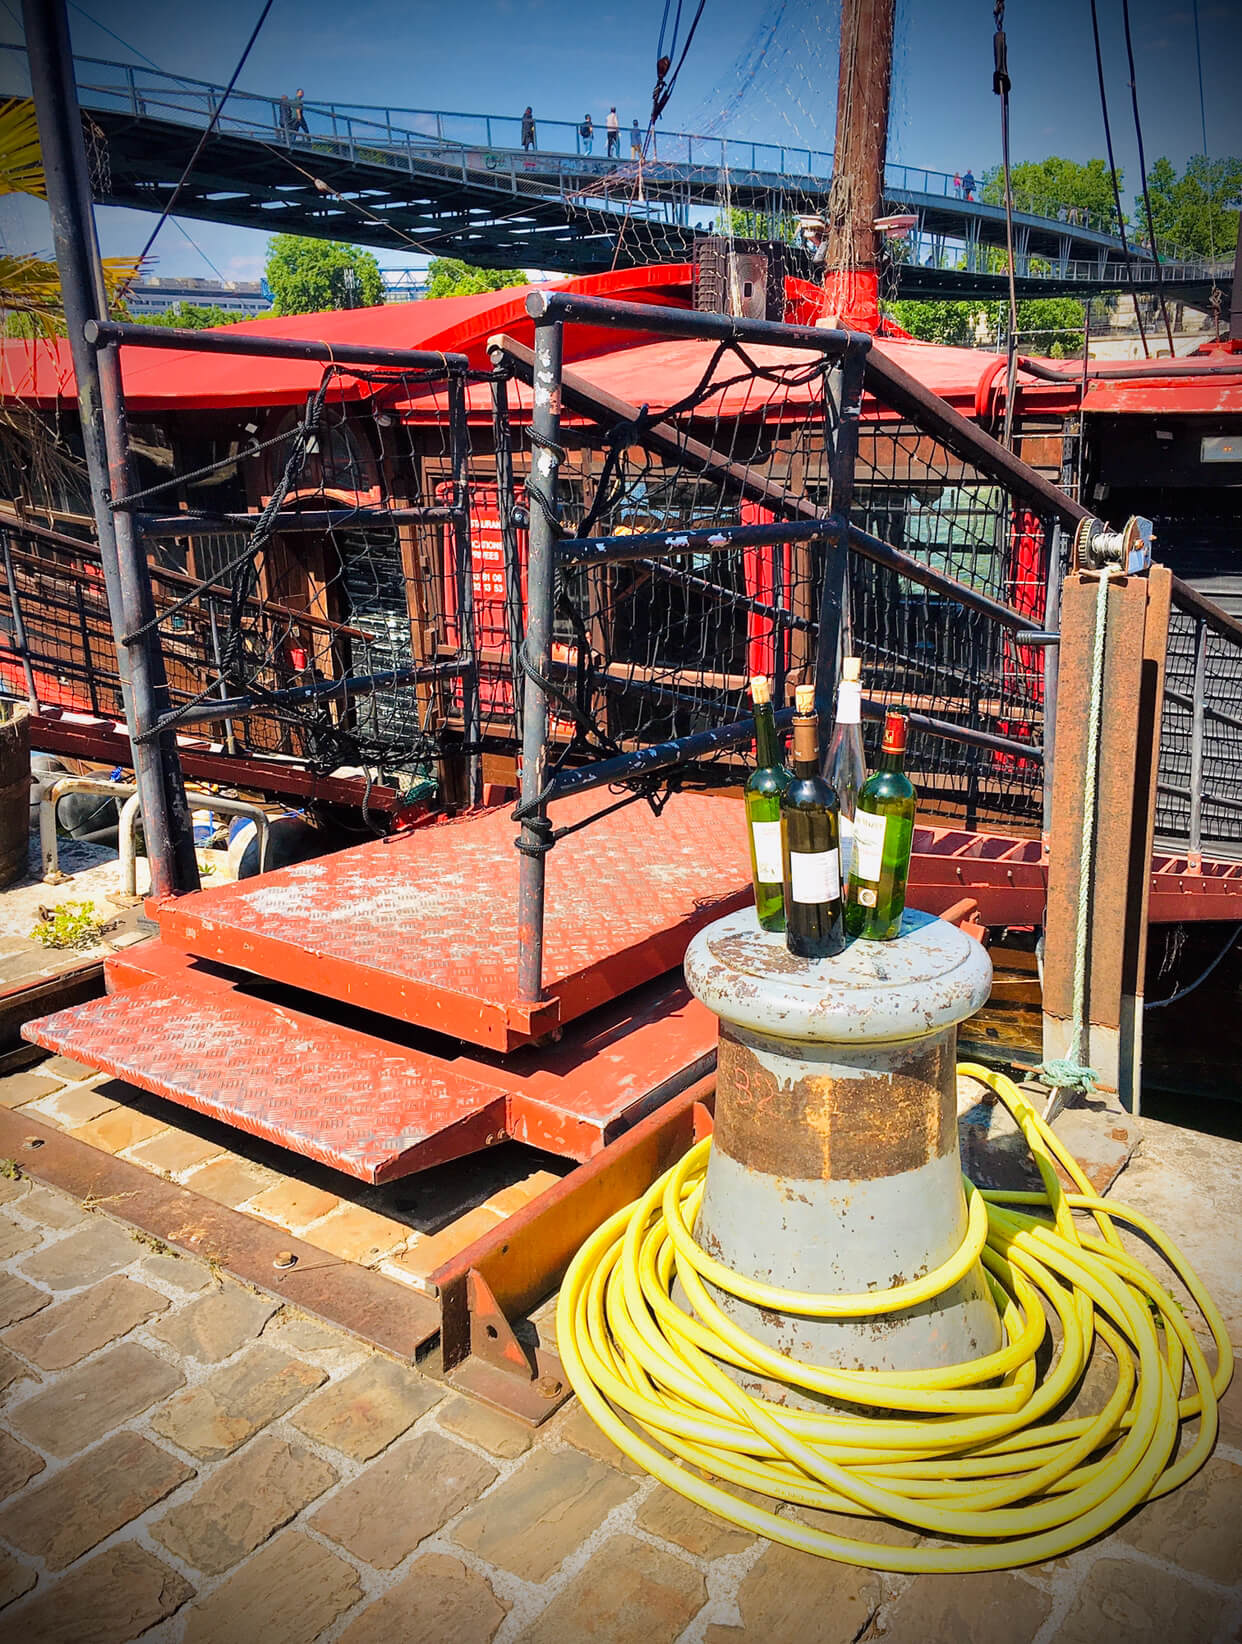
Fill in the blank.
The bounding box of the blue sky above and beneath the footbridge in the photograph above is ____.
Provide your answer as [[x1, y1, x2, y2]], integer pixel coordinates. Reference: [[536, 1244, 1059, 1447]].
[[0, 0, 1242, 278]]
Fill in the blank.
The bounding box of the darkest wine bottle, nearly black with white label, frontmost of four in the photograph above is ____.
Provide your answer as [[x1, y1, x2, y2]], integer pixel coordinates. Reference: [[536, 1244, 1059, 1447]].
[[781, 686, 846, 958]]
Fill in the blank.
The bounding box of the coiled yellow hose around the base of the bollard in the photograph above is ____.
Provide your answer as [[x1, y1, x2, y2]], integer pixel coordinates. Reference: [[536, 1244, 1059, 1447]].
[[556, 1064, 1234, 1572]]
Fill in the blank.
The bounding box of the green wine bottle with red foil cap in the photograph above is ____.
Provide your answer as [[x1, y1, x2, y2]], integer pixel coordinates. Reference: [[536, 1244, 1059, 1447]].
[[846, 709, 915, 942]]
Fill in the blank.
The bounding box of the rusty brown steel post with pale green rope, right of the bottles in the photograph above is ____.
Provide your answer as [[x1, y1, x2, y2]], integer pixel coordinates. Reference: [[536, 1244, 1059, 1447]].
[[1043, 566, 1173, 1113]]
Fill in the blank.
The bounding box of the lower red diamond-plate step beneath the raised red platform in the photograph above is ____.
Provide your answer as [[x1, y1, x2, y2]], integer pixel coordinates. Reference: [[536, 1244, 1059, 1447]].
[[25, 940, 717, 1182]]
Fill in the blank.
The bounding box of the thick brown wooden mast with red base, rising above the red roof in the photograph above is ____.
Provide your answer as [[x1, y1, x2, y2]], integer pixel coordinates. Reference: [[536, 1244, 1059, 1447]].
[[824, 0, 895, 330]]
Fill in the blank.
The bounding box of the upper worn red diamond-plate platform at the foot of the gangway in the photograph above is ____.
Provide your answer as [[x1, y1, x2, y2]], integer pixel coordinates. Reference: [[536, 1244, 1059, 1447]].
[[160, 794, 750, 1051]]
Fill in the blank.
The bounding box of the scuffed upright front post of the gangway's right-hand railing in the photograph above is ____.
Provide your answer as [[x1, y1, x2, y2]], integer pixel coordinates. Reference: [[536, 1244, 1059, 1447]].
[[518, 319, 561, 1003]]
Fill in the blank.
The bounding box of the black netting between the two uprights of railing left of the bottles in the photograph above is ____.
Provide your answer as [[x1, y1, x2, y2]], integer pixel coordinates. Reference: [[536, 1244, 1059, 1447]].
[[520, 342, 836, 796]]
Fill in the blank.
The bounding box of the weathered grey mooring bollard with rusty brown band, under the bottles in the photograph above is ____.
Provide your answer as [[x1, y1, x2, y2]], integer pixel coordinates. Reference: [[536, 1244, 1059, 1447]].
[[686, 907, 1002, 1404]]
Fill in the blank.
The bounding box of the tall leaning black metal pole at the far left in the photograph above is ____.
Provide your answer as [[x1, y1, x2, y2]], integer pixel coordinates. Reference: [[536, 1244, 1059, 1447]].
[[23, 0, 199, 896]]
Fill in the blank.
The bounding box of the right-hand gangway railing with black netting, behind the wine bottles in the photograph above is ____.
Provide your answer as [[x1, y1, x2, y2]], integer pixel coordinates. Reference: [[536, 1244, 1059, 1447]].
[[492, 293, 1082, 1001]]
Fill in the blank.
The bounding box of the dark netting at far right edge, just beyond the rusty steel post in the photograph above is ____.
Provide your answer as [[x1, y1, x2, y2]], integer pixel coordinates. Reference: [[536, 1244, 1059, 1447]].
[[1156, 602, 1242, 858]]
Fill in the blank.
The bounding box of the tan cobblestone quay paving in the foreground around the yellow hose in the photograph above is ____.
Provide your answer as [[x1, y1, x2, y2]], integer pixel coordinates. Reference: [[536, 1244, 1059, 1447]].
[[0, 1126, 1242, 1644]]
